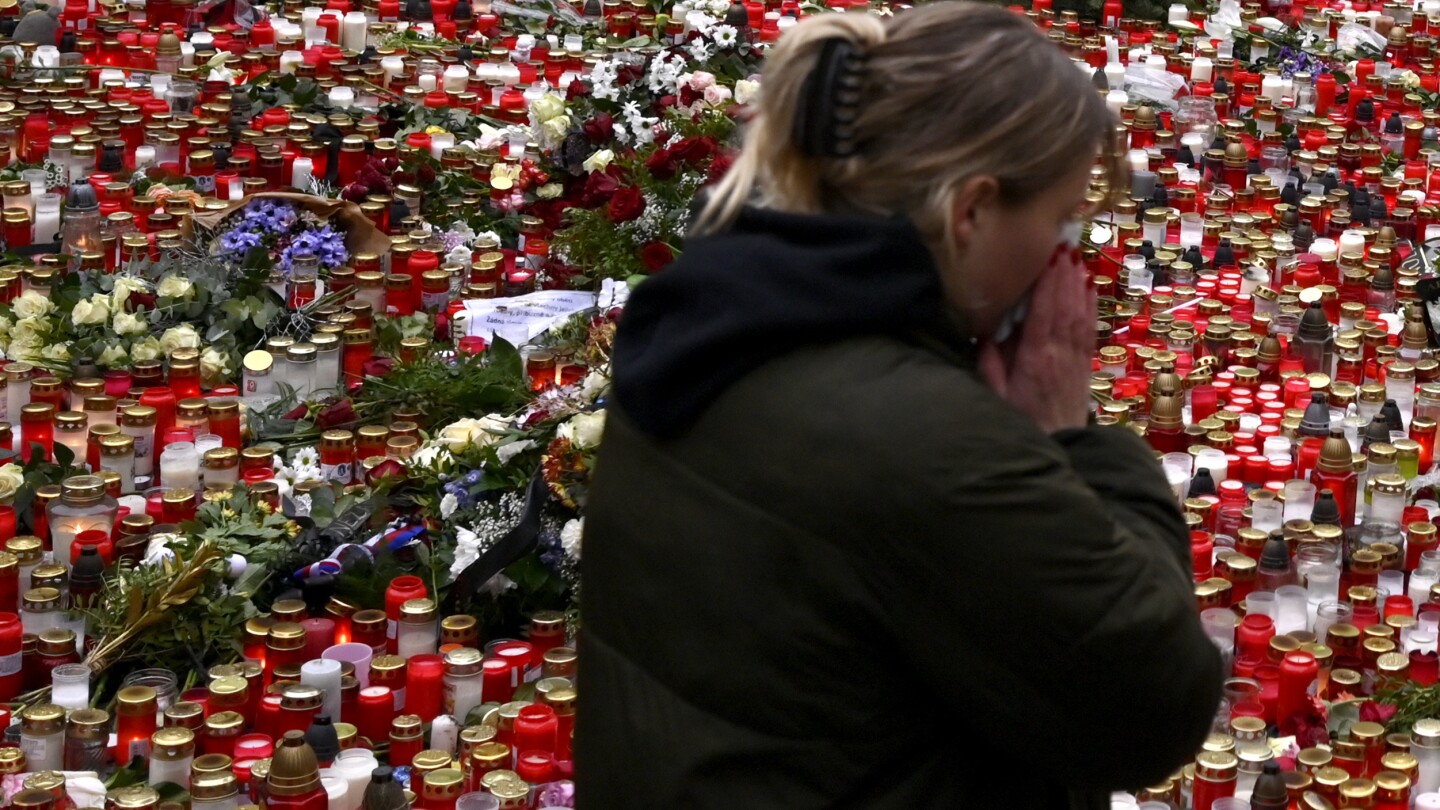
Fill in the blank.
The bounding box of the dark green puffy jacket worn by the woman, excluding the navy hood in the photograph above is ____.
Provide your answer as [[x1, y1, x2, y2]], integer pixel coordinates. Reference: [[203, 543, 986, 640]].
[[575, 206, 1223, 810]]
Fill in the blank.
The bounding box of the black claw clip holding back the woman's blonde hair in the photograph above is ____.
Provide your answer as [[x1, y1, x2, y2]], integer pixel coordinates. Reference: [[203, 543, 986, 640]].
[[795, 37, 865, 157]]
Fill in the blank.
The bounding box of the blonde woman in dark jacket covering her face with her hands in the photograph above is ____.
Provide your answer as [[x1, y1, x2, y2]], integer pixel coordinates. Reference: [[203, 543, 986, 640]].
[[576, 3, 1223, 810]]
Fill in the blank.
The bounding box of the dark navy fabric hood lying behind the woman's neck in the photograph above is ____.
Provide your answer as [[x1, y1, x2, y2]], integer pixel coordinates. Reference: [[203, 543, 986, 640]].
[[613, 209, 943, 438]]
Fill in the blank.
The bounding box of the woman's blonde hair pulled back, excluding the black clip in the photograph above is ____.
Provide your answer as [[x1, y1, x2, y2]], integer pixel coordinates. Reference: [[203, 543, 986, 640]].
[[691, 1, 1122, 269]]
